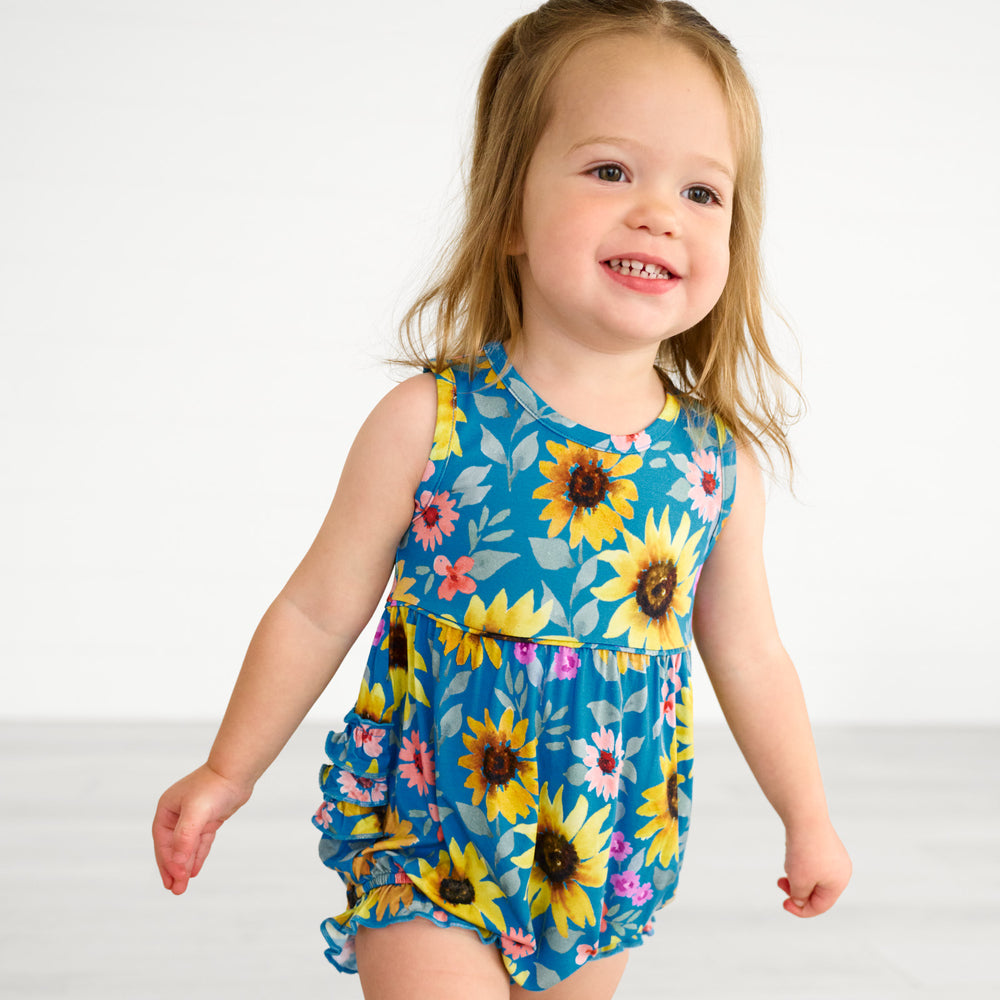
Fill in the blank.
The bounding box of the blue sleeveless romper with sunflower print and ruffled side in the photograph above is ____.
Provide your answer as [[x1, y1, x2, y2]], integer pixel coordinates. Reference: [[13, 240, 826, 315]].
[[314, 344, 735, 990]]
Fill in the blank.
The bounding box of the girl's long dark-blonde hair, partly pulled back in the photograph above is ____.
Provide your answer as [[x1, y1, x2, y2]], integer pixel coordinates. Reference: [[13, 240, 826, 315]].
[[400, 0, 801, 468]]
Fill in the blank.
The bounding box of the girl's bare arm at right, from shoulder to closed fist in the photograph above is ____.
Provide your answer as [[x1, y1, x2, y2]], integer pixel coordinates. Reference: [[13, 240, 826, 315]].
[[693, 450, 851, 917]]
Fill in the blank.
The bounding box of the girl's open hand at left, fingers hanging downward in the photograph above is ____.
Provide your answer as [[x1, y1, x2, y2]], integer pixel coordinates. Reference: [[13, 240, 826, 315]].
[[153, 764, 253, 896]]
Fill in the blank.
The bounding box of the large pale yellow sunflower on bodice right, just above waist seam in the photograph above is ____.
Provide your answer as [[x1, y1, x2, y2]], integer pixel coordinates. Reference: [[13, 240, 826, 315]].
[[591, 509, 705, 649]]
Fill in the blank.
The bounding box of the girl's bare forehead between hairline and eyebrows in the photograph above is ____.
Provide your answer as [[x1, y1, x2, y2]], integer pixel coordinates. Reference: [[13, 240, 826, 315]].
[[543, 35, 735, 174]]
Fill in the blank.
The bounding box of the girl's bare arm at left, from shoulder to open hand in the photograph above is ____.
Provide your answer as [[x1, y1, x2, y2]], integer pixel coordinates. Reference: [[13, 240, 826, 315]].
[[153, 375, 437, 894]]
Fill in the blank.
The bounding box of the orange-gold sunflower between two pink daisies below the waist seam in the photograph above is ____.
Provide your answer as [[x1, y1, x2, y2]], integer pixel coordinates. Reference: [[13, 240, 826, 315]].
[[458, 708, 538, 823]]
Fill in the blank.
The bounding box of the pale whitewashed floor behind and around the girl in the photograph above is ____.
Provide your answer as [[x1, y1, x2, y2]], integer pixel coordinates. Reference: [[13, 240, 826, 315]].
[[0, 723, 1000, 1000]]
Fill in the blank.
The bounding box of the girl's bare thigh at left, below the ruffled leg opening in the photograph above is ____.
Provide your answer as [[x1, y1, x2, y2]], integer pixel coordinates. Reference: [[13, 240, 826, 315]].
[[355, 917, 508, 1000]]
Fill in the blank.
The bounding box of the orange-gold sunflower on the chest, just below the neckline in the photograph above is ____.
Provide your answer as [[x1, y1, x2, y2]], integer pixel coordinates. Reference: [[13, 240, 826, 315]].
[[531, 441, 642, 549]]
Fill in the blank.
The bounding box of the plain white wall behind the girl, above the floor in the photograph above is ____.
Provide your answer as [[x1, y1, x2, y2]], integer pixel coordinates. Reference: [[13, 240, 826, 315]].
[[0, 0, 1000, 724]]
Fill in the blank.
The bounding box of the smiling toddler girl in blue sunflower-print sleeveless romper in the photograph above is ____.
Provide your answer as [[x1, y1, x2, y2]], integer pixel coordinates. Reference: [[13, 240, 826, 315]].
[[153, 0, 850, 1000]]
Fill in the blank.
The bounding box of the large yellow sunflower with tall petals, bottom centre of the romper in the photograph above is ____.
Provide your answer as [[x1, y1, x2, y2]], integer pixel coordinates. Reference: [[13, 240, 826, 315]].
[[513, 783, 612, 937]]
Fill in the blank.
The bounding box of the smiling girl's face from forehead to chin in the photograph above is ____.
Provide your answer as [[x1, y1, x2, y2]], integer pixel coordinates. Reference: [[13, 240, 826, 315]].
[[513, 36, 735, 352]]
